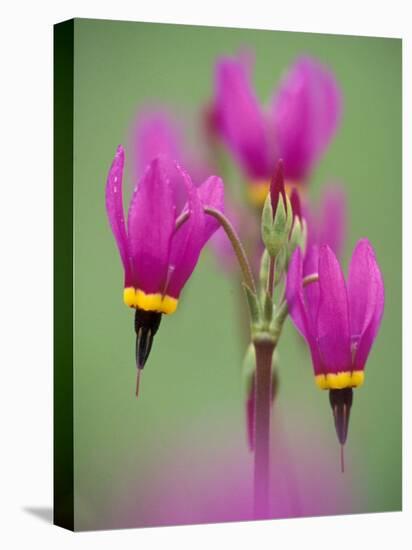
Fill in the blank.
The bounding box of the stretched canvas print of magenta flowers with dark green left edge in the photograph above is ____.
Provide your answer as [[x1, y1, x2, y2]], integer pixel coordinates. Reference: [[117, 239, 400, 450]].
[[54, 19, 402, 530]]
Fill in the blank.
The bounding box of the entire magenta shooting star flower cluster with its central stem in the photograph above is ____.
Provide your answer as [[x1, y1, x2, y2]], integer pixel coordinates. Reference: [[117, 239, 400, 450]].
[[106, 54, 384, 486]]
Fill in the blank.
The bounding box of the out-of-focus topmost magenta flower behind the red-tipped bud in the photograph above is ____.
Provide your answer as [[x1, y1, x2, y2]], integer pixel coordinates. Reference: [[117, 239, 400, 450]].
[[213, 57, 341, 205]]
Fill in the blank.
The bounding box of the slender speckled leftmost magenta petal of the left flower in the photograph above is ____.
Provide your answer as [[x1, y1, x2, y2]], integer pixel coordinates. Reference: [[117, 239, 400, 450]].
[[106, 145, 132, 286]]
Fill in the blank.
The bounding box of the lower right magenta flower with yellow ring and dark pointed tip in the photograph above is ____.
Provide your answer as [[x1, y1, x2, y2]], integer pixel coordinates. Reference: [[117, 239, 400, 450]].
[[286, 244, 385, 469]]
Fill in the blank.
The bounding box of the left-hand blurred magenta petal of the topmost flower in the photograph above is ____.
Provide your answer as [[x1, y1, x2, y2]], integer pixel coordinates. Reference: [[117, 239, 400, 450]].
[[214, 58, 270, 178]]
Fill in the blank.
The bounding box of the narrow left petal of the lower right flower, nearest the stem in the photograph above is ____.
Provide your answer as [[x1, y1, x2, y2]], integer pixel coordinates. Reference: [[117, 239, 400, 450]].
[[286, 247, 323, 374]]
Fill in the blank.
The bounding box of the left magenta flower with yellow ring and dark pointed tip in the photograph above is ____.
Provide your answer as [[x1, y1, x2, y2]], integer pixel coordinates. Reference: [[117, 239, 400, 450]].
[[106, 146, 223, 390]]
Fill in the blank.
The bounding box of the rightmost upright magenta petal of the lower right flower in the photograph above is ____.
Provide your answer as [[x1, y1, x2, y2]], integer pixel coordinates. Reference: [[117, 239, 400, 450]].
[[348, 239, 385, 369]]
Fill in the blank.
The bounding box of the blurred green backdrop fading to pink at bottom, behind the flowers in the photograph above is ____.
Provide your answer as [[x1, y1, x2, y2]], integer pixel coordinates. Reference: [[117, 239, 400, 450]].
[[74, 20, 402, 529]]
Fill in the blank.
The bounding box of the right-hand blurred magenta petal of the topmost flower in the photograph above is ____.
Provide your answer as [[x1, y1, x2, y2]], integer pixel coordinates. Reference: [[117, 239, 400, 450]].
[[273, 57, 341, 181]]
